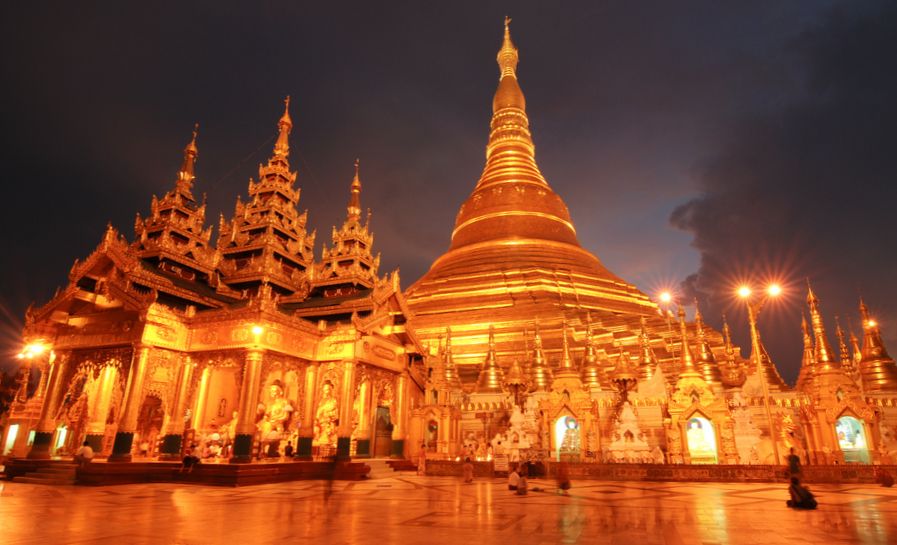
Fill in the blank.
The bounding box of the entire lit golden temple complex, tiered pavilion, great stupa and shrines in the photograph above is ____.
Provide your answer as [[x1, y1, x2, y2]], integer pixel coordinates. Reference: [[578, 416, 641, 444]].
[[0, 21, 897, 470]]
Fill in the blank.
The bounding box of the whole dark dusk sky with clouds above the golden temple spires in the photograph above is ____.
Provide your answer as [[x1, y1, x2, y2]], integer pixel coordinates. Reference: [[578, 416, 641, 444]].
[[0, 0, 897, 382]]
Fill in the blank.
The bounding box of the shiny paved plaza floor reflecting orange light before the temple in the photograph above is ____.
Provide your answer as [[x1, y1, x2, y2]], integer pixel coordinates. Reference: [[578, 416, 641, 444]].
[[0, 474, 897, 545]]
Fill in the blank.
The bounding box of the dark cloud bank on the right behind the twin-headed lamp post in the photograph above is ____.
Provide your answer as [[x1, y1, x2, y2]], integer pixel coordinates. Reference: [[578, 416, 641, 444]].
[[670, 2, 897, 380]]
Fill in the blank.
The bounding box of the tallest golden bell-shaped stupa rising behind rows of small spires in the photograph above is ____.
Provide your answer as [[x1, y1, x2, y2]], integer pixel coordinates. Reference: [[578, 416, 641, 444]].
[[406, 21, 723, 381]]
